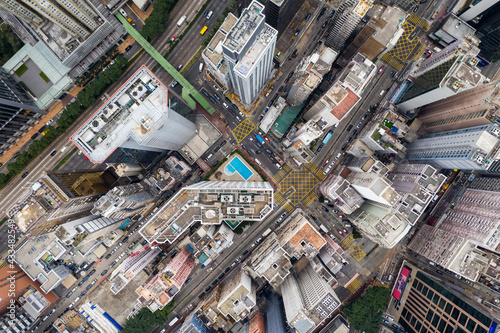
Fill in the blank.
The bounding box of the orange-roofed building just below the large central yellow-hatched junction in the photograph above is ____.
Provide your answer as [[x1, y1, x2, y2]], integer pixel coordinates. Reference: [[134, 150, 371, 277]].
[[277, 210, 326, 259]]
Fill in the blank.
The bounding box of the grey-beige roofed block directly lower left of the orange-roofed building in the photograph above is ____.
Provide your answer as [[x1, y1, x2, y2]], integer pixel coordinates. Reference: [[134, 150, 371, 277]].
[[246, 232, 292, 288]]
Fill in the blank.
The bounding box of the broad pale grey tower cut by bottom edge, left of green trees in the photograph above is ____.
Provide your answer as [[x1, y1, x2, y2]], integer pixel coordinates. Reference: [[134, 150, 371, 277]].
[[281, 265, 340, 333]]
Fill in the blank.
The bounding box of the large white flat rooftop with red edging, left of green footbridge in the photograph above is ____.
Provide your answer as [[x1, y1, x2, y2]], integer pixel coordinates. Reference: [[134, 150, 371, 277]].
[[71, 66, 170, 163]]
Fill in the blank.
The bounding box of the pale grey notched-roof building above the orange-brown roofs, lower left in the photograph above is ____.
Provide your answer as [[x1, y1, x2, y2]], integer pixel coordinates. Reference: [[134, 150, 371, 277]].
[[14, 233, 71, 293]]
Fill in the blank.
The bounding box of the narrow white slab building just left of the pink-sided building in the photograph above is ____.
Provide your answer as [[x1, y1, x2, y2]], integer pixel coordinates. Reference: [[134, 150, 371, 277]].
[[109, 246, 161, 295]]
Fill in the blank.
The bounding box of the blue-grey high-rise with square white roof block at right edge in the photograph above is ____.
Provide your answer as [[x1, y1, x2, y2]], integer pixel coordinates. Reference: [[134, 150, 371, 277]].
[[407, 124, 500, 170]]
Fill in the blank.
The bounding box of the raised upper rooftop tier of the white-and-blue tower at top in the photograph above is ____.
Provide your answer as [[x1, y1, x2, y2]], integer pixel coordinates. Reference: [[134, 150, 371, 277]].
[[224, 1, 265, 53]]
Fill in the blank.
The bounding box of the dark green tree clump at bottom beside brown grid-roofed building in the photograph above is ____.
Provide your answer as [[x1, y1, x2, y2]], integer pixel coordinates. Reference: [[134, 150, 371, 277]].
[[344, 287, 390, 333]]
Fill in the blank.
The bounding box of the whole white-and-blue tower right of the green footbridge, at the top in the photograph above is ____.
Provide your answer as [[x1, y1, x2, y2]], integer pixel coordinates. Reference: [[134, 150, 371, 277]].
[[222, 0, 278, 106]]
